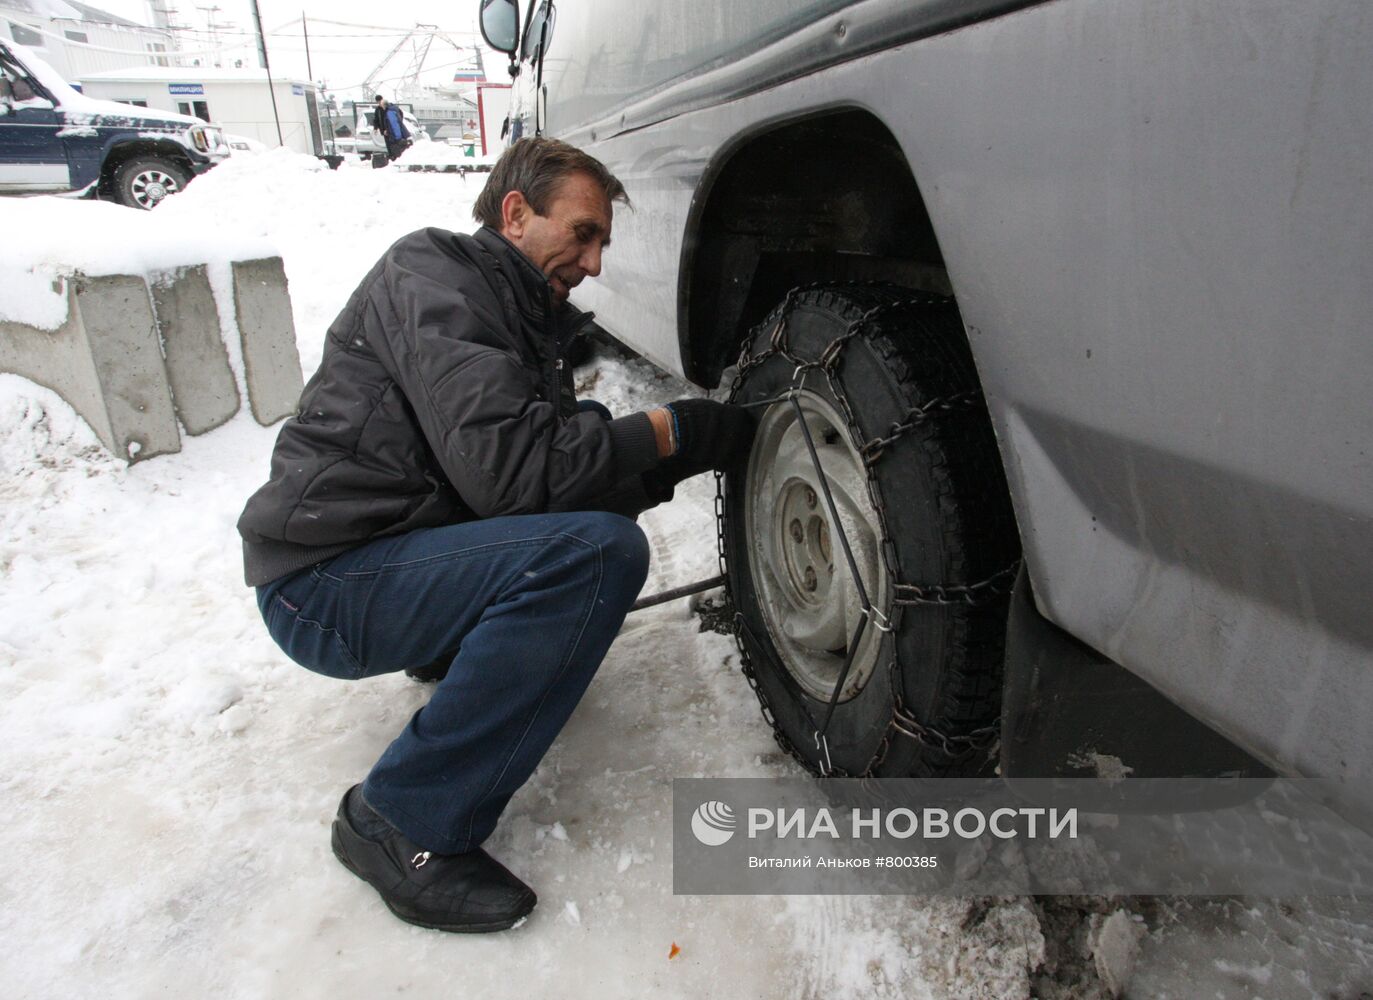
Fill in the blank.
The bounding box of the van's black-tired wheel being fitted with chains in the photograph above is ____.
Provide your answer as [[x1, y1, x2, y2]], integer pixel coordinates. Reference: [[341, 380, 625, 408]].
[[721, 284, 1019, 776]]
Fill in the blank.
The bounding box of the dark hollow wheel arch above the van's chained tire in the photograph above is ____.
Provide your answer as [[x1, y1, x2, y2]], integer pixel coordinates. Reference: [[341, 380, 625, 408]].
[[678, 104, 951, 386]]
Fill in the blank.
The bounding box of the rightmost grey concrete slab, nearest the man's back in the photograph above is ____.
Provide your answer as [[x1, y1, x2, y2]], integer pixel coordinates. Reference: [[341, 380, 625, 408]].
[[233, 257, 305, 426]]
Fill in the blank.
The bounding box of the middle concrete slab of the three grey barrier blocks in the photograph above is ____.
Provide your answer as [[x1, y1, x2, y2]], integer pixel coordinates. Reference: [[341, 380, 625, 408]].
[[150, 264, 239, 434]]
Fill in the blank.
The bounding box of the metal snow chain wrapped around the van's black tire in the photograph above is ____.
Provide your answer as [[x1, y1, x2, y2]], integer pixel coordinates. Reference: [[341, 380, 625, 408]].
[[715, 282, 1020, 779]]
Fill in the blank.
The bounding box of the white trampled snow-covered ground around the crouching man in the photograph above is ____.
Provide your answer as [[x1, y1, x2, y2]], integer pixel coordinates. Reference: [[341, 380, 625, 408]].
[[0, 151, 1373, 1000]]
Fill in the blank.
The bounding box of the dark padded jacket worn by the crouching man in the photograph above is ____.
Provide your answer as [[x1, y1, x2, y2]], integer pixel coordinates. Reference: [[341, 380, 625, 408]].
[[239, 228, 658, 587]]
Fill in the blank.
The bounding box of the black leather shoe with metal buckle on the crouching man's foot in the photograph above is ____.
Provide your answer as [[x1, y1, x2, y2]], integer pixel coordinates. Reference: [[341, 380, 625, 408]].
[[332, 784, 538, 933]]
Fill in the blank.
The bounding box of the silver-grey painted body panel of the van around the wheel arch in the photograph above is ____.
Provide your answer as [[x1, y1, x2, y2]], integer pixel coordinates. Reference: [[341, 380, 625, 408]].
[[516, 0, 1373, 798]]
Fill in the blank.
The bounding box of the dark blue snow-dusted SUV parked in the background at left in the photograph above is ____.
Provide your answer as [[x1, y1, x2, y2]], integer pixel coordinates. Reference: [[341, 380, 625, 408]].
[[0, 41, 229, 209]]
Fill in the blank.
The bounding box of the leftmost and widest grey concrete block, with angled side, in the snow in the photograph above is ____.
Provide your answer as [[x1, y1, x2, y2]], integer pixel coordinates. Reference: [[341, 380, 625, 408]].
[[0, 275, 181, 462]]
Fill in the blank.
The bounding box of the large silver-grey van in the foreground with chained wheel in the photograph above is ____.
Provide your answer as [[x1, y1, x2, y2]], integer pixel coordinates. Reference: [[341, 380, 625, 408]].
[[481, 0, 1373, 816]]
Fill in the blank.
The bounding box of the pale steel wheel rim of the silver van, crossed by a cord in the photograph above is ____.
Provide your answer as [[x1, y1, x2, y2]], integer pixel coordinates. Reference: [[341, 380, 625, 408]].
[[744, 390, 891, 701]]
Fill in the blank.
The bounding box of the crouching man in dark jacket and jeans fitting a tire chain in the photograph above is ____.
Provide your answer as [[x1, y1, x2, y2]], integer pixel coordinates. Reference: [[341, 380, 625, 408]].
[[239, 139, 754, 931]]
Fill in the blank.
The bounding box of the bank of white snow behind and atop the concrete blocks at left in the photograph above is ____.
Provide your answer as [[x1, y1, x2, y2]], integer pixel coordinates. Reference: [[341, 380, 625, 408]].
[[0, 148, 485, 372]]
